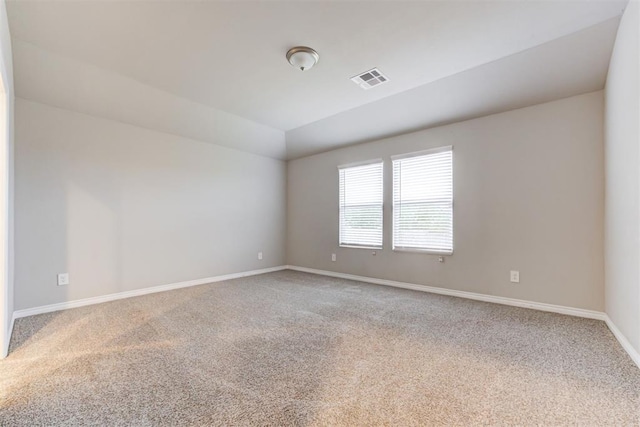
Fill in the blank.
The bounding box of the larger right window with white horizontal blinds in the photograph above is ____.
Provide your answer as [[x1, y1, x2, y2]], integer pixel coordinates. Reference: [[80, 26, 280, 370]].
[[392, 147, 453, 254]]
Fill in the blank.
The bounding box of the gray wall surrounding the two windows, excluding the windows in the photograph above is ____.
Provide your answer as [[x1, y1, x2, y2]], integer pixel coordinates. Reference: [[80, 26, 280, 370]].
[[287, 91, 604, 311]]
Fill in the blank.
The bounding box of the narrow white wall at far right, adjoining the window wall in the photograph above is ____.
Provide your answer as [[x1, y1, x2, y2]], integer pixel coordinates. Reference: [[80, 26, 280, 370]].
[[605, 1, 640, 352]]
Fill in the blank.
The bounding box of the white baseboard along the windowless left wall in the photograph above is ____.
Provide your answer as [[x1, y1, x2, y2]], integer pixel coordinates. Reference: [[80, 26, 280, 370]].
[[13, 265, 287, 319]]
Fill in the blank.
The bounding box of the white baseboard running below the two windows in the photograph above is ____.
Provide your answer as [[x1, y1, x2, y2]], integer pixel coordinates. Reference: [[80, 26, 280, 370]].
[[287, 265, 605, 320]]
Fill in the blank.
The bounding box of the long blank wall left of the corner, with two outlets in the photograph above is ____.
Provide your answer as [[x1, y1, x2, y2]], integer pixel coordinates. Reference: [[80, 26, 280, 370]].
[[15, 98, 286, 310]]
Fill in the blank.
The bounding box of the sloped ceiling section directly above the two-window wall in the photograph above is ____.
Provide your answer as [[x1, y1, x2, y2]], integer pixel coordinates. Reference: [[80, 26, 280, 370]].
[[286, 18, 619, 158]]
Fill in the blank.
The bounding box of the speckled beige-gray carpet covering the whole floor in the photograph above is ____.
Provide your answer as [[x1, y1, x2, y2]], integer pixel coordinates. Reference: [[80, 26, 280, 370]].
[[0, 271, 640, 426]]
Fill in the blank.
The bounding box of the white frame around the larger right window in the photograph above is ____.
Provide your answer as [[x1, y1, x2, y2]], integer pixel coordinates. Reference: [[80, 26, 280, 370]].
[[391, 145, 455, 256]]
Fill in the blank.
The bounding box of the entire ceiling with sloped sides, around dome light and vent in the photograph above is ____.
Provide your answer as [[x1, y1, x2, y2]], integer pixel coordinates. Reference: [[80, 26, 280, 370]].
[[8, 0, 626, 158]]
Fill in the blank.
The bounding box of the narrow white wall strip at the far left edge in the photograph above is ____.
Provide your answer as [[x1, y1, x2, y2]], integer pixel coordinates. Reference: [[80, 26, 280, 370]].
[[0, 0, 14, 357]]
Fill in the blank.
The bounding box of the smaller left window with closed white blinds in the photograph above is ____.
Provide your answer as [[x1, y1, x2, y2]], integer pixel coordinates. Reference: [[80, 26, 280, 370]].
[[338, 160, 382, 249]]
